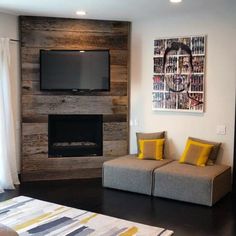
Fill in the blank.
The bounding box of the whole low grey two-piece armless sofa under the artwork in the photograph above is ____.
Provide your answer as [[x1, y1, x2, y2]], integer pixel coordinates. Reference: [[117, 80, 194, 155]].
[[103, 155, 231, 206]]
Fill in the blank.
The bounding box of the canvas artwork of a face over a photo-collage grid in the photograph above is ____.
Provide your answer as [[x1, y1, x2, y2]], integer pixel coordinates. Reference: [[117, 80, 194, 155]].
[[152, 36, 206, 112]]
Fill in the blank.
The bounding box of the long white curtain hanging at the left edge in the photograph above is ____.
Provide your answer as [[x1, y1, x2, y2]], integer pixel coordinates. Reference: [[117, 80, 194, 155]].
[[0, 38, 19, 192]]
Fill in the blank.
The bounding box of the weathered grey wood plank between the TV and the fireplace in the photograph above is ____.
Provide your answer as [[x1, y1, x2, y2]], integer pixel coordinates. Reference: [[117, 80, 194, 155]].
[[22, 95, 128, 116]]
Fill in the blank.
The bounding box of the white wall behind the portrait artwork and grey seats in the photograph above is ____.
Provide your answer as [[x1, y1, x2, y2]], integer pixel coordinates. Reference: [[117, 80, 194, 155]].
[[130, 5, 236, 165]]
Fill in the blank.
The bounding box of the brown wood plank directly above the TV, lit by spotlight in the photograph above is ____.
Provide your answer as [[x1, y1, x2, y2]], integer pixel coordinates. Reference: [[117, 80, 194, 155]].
[[21, 30, 128, 50]]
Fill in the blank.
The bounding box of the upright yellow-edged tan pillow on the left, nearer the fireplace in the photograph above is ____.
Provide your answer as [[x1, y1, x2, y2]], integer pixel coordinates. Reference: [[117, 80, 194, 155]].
[[138, 139, 165, 160]]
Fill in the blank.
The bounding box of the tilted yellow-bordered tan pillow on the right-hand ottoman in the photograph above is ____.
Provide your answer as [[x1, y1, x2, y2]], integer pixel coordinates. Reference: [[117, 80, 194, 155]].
[[179, 139, 213, 166]]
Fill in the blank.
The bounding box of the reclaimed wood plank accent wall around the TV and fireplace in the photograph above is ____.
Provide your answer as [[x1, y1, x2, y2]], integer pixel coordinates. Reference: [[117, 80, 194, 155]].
[[19, 16, 130, 181]]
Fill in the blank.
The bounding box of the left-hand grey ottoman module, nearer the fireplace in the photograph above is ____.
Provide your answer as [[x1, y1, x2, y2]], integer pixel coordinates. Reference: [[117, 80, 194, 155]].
[[103, 155, 172, 195]]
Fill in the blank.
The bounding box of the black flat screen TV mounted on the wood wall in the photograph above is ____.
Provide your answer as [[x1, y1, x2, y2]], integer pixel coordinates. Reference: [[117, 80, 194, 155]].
[[40, 50, 110, 91]]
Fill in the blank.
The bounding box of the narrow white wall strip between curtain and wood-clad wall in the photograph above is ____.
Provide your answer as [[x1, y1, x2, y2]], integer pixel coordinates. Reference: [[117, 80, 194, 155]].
[[0, 13, 20, 171]]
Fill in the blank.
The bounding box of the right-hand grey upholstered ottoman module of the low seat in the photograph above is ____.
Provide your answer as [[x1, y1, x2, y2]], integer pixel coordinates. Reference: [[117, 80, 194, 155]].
[[153, 161, 231, 206]]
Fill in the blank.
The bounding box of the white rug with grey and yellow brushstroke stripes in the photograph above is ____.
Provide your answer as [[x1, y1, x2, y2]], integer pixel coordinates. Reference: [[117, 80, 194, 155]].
[[0, 196, 173, 236]]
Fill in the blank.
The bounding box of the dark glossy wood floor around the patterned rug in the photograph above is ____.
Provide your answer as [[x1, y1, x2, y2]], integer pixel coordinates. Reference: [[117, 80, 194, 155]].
[[0, 179, 236, 236]]
